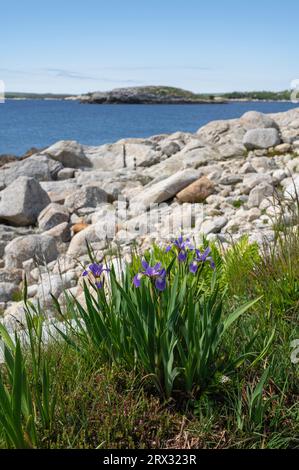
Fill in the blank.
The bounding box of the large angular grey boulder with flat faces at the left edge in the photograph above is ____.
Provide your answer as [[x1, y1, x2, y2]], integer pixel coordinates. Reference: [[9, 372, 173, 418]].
[[0, 176, 50, 225]]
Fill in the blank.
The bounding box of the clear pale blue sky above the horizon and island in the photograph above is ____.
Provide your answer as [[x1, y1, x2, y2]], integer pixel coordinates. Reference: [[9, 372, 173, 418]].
[[0, 0, 299, 93]]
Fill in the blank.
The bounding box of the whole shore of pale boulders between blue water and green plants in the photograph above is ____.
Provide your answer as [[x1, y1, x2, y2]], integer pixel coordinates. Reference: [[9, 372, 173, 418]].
[[0, 108, 299, 329]]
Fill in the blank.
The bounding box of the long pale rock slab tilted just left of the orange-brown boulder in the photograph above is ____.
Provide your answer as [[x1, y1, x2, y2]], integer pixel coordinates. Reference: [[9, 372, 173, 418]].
[[131, 170, 199, 209]]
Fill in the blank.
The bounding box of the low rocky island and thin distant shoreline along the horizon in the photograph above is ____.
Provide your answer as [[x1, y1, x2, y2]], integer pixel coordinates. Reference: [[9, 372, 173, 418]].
[[5, 86, 290, 104]]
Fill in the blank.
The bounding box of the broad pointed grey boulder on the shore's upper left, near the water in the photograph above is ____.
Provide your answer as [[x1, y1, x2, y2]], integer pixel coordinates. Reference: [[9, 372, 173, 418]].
[[42, 140, 91, 168]]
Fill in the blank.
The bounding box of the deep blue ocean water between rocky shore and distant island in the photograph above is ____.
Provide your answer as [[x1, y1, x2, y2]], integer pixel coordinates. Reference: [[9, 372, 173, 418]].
[[0, 100, 298, 155]]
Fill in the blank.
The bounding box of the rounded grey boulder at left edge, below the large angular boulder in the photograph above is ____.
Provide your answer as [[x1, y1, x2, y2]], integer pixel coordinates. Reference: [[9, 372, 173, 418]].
[[4, 235, 58, 269]]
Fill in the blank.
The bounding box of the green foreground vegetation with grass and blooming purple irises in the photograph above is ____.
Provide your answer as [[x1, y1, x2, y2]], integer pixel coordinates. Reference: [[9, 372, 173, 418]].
[[0, 216, 299, 448]]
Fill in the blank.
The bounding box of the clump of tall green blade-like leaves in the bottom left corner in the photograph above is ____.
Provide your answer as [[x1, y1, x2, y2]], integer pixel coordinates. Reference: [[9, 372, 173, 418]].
[[0, 305, 56, 448]]
